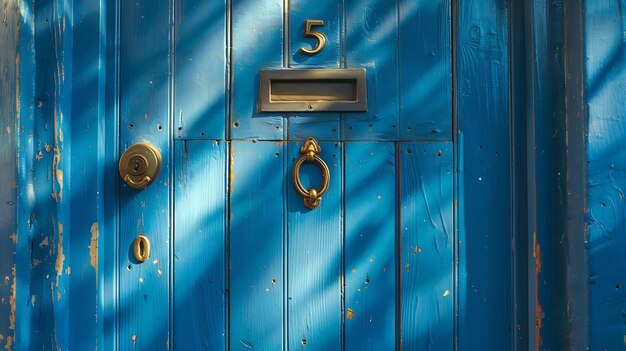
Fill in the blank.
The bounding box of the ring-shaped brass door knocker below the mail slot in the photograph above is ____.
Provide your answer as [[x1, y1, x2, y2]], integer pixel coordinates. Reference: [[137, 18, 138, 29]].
[[293, 138, 330, 210]]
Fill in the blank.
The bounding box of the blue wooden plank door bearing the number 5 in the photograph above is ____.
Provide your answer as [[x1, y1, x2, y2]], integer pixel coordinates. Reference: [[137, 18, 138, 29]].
[[116, 0, 512, 351]]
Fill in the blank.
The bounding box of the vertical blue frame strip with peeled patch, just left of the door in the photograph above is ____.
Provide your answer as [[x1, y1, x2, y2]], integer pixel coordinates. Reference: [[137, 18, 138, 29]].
[[64, 0, 102, 350]]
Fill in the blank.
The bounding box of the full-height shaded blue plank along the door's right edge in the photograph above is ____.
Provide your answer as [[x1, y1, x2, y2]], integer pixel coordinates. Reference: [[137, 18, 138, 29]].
[[455, 0, 513, 350]]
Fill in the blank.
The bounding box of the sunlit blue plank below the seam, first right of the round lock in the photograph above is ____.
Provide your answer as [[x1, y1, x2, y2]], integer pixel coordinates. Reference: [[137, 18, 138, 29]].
[[173, 141, 226, 350]]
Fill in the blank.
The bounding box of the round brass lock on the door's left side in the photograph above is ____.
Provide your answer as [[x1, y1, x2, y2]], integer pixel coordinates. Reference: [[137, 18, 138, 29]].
[[119, 142, 162, 190]]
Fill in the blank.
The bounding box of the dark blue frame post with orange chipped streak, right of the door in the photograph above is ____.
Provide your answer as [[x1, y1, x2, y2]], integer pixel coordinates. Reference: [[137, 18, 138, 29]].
[[528, 2, 572, 350]]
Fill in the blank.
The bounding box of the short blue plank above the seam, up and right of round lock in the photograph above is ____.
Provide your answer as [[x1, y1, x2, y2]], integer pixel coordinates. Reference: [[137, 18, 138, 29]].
[[174, 0, 228, 139]]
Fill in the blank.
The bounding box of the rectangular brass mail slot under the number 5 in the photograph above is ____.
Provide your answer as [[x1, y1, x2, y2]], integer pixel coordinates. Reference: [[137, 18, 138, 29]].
[[259, 68, 367, 112]]
